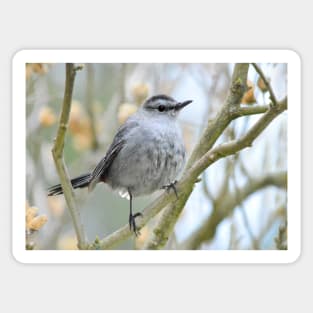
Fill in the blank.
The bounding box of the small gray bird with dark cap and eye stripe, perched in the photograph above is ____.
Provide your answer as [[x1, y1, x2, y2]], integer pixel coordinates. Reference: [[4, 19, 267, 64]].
[[48, 94, 192, 236]]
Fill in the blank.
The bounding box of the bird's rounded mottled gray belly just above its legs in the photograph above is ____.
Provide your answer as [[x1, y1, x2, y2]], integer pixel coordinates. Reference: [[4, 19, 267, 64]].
[[106, 138, 185, 197]]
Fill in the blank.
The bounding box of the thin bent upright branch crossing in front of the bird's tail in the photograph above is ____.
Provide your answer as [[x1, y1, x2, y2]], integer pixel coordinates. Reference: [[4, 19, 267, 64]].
[[52, 63, 86, 249]]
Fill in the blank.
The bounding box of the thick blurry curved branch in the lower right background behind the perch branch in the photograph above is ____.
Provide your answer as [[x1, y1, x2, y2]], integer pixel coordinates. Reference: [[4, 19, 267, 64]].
[[180, 172, 287, 249]]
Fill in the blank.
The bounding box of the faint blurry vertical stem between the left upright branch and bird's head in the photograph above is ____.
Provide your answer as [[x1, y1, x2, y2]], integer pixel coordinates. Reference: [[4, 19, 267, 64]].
[[86, 63, 99, 150]]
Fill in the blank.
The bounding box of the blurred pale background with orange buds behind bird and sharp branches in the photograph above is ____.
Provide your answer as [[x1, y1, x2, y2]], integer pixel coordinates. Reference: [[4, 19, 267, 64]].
[[26, 63, 286, 250]]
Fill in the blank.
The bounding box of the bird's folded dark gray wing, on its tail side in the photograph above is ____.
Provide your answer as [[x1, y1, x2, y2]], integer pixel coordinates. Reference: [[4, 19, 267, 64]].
[[88, 121, 138, 191]]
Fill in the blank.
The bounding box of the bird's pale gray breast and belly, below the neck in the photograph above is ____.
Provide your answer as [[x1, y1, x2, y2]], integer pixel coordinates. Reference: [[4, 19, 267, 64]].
[[107, 120, 185, 196]]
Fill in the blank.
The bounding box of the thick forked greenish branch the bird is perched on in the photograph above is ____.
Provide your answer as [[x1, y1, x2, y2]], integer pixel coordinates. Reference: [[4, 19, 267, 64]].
[[89, 64, 287, 249]]
